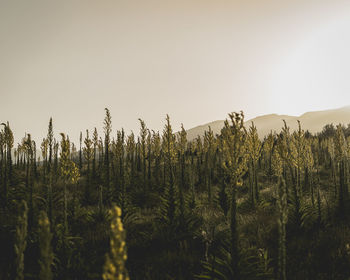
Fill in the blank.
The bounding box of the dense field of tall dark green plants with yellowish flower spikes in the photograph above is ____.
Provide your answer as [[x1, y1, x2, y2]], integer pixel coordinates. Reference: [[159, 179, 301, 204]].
[[0, 109, 350, 280]]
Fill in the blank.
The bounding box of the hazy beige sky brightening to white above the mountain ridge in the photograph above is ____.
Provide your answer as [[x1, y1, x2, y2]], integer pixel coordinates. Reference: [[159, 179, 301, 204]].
[[0, 0, 350, 145]]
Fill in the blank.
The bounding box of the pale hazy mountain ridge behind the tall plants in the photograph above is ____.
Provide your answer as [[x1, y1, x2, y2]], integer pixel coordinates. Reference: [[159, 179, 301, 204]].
[[187, 106, 350, 141]]
